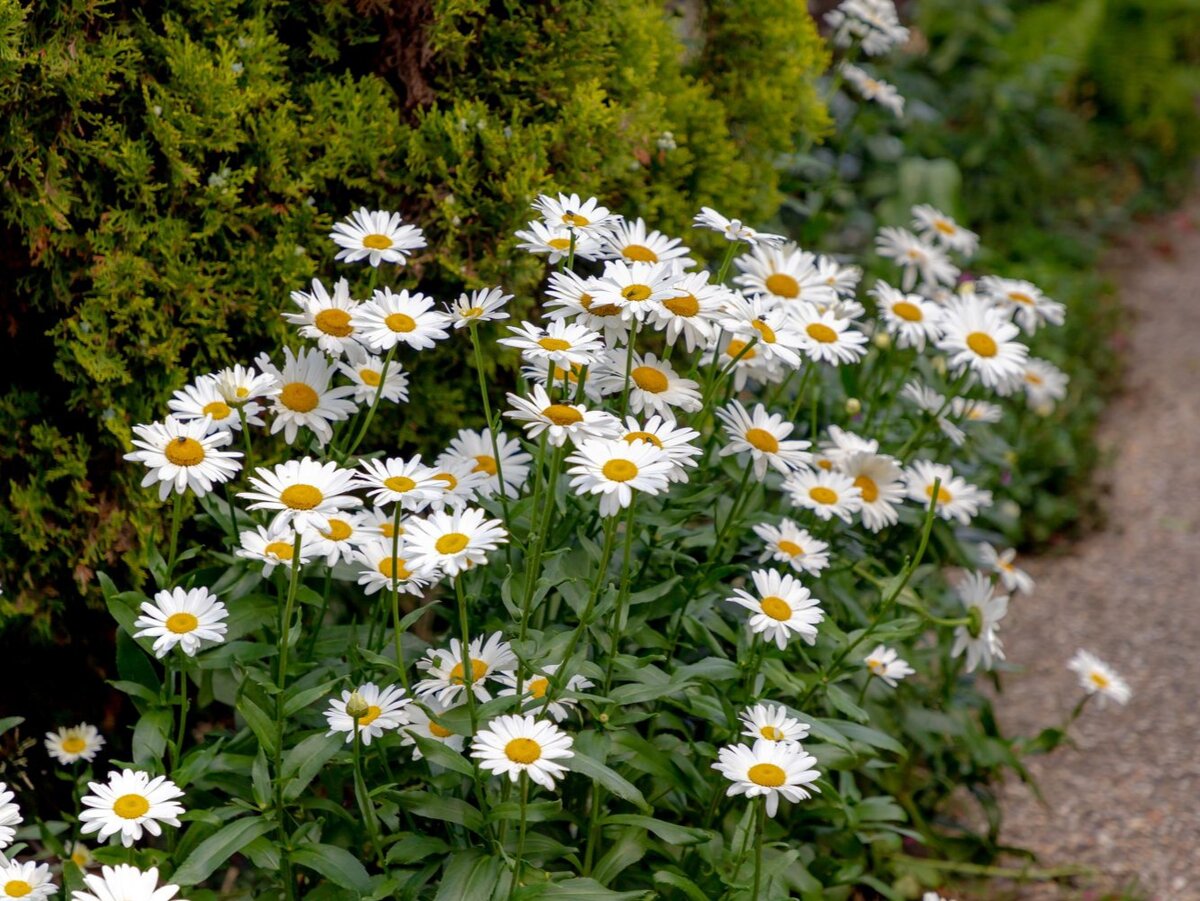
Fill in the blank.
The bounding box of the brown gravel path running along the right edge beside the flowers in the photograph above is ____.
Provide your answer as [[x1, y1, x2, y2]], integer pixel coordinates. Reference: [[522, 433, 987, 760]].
[[997, 203, 1200, 901]]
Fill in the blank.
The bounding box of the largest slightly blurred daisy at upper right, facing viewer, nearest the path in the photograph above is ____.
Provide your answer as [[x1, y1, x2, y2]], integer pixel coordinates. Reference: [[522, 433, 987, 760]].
[[937, 298, 1030, 389]]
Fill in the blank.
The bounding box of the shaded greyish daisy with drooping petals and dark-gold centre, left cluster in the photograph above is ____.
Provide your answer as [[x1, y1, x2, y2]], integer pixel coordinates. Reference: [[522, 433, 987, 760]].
[[256, 347, 355, 446]]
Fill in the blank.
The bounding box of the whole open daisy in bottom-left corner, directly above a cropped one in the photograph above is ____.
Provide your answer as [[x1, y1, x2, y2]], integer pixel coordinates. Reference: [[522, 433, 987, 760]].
[[79, 769, 184, 848]]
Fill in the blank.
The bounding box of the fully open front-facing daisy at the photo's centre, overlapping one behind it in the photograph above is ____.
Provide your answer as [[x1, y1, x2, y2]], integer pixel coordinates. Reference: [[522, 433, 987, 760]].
[[566, 438, 673, 516]]
